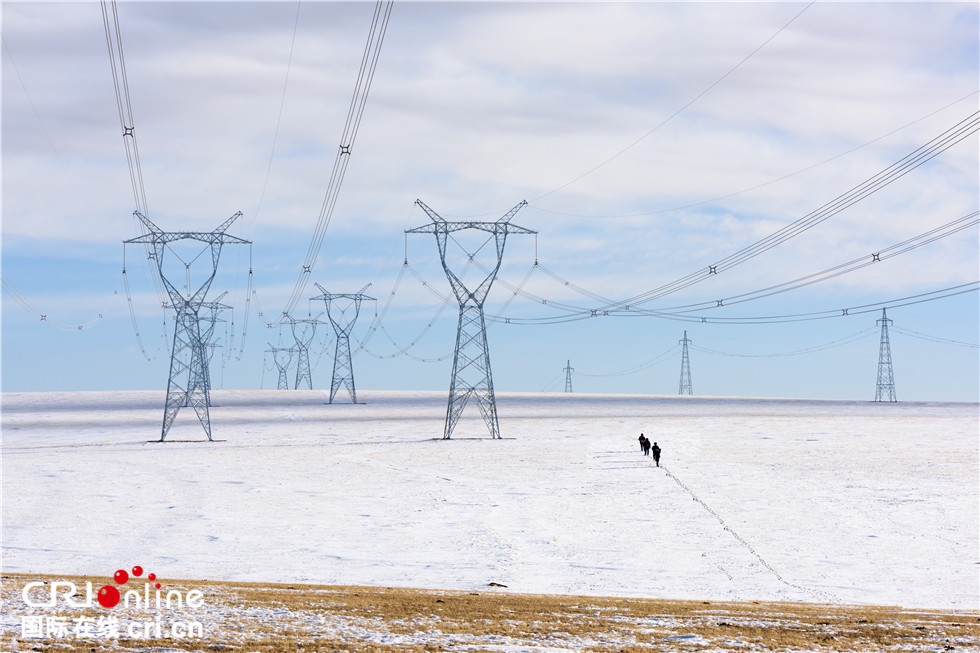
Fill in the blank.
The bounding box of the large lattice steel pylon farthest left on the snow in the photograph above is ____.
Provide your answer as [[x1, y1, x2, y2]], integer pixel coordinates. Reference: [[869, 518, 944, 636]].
[[123, 211, 251, 442]]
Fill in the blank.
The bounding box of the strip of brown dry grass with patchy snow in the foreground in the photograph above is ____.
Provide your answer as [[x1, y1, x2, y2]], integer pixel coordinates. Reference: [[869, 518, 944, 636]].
[[0, 574, 980, 653]]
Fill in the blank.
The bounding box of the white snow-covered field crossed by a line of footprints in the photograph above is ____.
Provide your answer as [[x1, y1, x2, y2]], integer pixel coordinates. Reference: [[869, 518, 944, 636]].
[[2, 391, 980, 609]]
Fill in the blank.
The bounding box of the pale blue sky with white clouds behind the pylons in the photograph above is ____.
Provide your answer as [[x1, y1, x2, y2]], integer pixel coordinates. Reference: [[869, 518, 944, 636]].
[[2, 2, 980, 401]]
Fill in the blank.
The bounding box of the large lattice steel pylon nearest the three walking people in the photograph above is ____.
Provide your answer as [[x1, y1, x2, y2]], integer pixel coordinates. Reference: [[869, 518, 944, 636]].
[[405, 200, 537, 440]]
